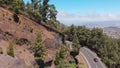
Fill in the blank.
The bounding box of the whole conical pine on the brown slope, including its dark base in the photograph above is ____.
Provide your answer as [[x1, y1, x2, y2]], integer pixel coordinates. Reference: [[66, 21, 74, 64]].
[[34, 33, 47, 68]]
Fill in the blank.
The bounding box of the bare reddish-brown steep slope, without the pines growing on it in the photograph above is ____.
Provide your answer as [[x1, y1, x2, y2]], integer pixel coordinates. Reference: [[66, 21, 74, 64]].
[[0, 7, 62, 68]]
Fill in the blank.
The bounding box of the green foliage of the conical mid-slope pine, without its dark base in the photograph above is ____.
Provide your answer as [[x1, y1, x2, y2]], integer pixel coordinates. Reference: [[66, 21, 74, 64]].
[[34, 33, 47, 60]]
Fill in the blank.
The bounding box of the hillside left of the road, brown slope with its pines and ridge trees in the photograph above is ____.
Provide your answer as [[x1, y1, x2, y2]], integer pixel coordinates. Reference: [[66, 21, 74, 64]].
[[0, 0, 79, 68]]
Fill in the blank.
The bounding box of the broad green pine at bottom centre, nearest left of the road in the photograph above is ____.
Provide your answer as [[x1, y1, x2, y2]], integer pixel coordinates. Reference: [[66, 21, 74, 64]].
[[54, 45, 70, 68]]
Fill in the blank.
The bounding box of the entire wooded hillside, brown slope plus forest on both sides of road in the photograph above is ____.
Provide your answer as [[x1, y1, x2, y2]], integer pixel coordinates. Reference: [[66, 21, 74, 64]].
[[0, 0, 120, 68]]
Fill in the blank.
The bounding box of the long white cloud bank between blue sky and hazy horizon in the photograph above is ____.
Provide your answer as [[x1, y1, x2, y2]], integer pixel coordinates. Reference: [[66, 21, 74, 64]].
[[57, 11, 120, 25]]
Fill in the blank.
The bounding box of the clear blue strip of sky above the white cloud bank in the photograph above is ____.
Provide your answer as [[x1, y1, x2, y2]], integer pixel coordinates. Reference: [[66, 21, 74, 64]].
[[50, 0, 120, 14]]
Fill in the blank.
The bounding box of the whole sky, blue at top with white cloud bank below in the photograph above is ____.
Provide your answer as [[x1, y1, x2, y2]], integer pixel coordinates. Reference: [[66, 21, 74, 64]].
[[25, 0, 120, 27]]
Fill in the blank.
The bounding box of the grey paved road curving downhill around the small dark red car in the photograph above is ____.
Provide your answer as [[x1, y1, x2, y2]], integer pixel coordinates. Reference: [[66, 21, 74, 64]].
[[80, 47, 106, 68]]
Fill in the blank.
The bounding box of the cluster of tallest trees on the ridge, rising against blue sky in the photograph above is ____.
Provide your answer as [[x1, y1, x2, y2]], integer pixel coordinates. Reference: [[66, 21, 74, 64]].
[[29, 0, 57, 22]]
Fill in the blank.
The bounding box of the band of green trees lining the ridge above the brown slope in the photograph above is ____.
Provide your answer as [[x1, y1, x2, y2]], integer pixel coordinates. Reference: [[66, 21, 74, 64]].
[[0, 0, 62, 30]]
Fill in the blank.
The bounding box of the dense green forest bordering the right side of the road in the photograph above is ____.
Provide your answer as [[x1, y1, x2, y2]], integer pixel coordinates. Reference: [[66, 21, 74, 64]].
[[64, 25, 120, 68]]
